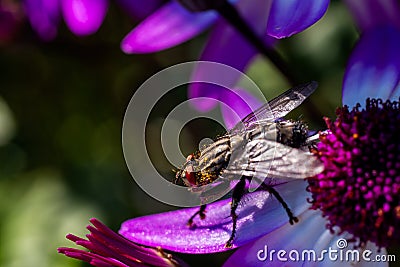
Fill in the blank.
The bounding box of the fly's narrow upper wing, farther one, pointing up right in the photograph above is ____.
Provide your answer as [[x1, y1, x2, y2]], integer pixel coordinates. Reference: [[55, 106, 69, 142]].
[[230, 81, 318, 133]]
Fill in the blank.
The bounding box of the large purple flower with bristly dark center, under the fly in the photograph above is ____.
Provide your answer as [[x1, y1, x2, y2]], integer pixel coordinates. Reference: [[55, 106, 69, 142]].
[[120, 0, 400, 266]]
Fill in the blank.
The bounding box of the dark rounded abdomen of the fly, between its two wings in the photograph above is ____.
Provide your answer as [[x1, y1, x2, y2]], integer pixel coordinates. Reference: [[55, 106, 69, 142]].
[[276, 120, 308, 148]]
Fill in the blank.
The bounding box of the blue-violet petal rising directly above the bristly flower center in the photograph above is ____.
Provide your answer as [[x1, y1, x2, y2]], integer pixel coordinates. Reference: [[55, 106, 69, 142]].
[[342, 27, 400, 107]]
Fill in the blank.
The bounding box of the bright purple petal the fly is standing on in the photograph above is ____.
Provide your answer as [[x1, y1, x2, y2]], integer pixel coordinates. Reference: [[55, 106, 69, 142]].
[[119, 180, 309, 253]]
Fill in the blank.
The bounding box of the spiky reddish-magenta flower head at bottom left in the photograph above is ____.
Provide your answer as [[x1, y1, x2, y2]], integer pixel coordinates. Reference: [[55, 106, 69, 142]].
[[58, 219, 187, 267]]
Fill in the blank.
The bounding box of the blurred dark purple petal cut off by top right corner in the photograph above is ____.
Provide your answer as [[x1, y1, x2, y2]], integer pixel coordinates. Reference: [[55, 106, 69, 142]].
[[345, 0, 400, 31]]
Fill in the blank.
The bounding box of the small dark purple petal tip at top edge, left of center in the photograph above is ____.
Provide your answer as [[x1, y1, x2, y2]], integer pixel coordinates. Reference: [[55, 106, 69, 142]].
[[117, 0, 165, 20]]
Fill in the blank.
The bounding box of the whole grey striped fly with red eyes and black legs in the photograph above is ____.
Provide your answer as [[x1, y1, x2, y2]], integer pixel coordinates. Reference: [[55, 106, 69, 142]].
[[175, 82, 322, 247]]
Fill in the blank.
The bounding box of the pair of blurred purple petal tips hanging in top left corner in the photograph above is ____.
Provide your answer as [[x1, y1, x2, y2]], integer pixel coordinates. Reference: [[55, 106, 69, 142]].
[[24, 0, 108, 40]]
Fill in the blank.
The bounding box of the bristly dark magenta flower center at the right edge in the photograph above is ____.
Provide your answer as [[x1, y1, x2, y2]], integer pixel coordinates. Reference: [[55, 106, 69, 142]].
[[309, 99, 400, 247]]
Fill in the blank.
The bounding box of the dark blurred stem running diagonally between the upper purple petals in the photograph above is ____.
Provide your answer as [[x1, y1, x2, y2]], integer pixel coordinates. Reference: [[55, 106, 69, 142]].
[[216, 1, 299, 86]]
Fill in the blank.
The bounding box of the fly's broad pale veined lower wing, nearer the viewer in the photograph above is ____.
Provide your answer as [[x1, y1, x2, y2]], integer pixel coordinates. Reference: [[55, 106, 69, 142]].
[[223, 139, 323, 182]]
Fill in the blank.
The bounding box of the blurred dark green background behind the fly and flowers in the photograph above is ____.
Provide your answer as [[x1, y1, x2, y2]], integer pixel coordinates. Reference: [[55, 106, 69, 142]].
[[0, 2, 396, 267]]
